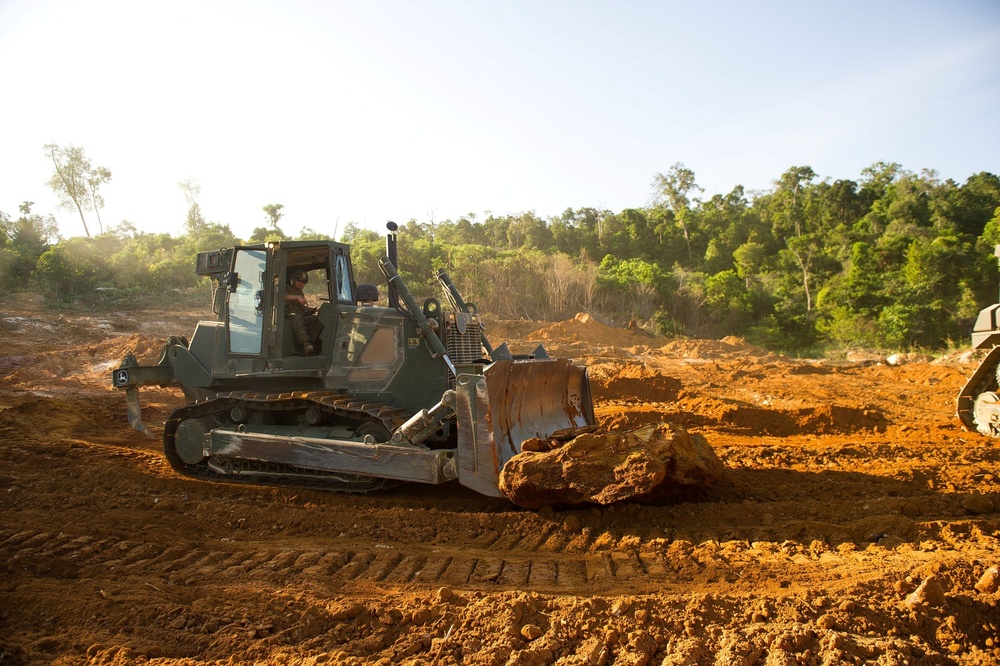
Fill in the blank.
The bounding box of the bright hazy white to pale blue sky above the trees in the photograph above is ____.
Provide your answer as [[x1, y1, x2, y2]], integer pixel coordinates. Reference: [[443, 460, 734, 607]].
[[0, 0, 1000, 237]]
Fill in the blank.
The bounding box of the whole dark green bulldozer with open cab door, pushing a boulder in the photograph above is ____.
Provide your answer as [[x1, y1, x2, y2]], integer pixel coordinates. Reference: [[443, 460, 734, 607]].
[[111, 222, 594, 497]]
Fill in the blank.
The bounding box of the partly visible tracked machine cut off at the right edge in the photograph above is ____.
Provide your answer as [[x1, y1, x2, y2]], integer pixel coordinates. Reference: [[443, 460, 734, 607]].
[[957, 245, 1000, 437]]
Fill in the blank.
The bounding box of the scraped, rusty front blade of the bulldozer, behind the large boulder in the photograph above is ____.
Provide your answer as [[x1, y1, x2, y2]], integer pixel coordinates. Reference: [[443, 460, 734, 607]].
[[456, 359, 594, 497]]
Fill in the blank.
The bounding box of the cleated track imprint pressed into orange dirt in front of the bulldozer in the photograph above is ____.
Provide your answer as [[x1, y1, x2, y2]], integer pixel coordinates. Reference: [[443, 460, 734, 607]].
[[0, 531, 704, 592]]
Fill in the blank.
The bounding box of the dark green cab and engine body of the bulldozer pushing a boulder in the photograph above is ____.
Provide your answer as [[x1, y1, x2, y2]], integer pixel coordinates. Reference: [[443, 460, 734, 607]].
[[188, 241, 454, 411]]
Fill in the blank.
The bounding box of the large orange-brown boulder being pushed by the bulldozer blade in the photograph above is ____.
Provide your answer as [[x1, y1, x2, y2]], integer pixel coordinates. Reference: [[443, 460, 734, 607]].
[[500, 423, 725, 509]]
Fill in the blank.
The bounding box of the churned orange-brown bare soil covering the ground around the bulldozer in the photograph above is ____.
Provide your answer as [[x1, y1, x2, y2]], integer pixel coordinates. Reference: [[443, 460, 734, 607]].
[[0, 296, 1000, 665]]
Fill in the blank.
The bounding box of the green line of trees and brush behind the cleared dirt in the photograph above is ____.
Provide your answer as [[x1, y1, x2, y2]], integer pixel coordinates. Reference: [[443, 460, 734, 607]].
[[0, 147, 1000, 353]]
